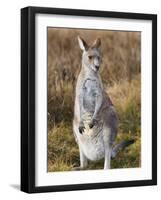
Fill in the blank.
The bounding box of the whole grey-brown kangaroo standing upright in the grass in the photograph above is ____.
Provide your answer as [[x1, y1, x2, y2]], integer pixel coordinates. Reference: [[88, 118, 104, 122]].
[[73, 36, 134, 170]]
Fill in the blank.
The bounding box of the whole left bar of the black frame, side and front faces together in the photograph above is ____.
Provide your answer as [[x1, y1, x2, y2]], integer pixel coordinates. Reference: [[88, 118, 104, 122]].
[[21, 7, 35, 193]]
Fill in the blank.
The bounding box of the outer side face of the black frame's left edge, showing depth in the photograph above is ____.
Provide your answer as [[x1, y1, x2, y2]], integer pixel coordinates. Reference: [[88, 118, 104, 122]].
[[21, 8, 29, 192]]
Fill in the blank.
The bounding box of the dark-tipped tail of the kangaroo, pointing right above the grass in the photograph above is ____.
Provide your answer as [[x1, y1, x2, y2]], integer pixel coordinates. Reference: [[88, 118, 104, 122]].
[[111, 140, 135, 158]]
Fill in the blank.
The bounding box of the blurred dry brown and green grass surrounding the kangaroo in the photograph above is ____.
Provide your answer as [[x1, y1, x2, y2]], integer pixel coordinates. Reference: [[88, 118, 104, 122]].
[[47, 28, 141, 172]]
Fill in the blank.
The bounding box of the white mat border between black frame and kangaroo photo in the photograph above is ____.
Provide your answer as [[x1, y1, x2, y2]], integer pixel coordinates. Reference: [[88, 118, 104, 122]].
[[35, 14, 152, 186]]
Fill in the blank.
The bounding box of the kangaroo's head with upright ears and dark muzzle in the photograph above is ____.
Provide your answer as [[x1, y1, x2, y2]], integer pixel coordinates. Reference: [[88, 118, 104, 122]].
[[78, 36, 101, 72]]
